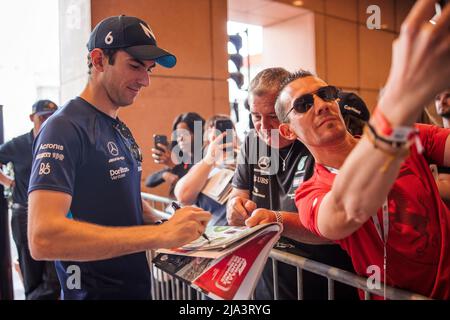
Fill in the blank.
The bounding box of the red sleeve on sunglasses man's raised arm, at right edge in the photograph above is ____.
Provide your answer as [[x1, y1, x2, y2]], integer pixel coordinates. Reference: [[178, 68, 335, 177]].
[[416, 124, 450, 166]]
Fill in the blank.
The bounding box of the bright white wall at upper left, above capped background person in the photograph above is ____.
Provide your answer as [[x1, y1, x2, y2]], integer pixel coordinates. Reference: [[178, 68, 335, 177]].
[[0, 0, 59, 140]]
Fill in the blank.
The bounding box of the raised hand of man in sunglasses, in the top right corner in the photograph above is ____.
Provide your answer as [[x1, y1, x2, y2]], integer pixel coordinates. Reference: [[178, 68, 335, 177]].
[[379, 0, 450, 125]]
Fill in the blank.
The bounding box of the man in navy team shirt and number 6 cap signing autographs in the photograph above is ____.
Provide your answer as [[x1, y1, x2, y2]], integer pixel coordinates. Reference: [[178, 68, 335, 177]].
[[28, 15, 210, 299]]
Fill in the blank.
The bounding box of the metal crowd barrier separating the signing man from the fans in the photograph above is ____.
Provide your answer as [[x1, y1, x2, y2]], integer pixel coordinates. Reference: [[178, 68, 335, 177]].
[[142, 193, 430, 300]]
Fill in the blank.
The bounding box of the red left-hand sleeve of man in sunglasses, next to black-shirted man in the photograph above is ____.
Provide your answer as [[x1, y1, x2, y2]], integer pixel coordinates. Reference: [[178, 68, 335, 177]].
[[295, 172, 331, 237]]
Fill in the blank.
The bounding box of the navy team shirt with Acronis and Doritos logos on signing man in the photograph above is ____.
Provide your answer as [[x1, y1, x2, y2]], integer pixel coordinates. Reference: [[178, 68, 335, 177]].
[[29, 97, 150, 299]]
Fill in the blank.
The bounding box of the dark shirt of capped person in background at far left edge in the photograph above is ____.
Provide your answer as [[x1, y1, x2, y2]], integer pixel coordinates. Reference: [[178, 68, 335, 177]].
[[0, 130, 33, 206]]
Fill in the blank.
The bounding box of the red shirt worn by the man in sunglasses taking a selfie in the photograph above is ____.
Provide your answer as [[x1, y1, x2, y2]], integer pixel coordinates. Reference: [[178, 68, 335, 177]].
[[296, 125, 450, 299]]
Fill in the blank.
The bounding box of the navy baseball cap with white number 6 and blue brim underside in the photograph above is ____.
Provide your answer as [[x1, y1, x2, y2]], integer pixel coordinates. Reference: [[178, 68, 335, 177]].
[[87, 15, 177, 68]]
